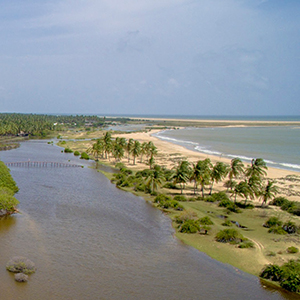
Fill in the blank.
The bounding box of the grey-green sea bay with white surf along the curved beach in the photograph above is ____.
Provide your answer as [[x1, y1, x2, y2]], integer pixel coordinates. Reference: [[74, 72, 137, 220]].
[[155, 125, 300, 172]]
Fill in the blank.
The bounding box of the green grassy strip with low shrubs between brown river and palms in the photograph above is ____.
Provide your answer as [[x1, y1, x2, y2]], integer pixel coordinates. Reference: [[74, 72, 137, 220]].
[[54, 127, 300, 292]]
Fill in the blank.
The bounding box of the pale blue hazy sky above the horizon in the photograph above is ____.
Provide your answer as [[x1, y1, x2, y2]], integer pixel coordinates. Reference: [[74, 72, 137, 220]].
[[0, 0, 300, 116]]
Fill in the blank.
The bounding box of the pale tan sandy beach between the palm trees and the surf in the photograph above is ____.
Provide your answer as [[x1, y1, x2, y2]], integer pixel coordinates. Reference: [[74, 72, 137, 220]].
[[112, 127, 300, 201]]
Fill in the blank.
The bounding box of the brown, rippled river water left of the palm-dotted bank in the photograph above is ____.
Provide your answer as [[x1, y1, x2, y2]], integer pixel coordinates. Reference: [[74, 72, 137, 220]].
[[0, 141, 299, 300]]
